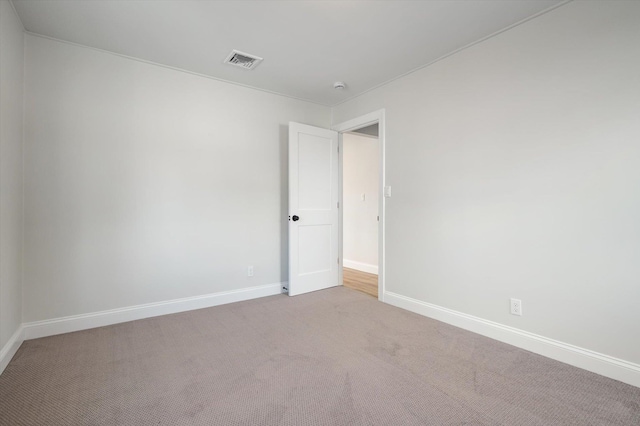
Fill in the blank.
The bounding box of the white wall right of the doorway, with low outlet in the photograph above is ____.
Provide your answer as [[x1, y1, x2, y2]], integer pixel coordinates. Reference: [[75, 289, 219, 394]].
[[333, 1, 640, 364]]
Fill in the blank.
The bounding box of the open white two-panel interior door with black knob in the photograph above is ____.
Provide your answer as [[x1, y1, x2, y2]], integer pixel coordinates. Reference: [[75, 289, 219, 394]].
[[289, 123, 340, 296]]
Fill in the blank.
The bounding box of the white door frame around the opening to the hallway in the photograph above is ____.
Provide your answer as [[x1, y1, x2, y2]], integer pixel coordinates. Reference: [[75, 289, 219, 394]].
[[331, 109, 386, 302]]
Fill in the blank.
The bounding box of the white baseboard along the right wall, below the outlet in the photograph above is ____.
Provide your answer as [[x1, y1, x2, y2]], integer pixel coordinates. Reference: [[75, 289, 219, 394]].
[[384, 291, 640, 387]]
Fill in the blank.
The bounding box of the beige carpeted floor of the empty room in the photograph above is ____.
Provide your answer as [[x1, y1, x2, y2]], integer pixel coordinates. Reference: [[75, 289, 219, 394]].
[[0, 287, 640, 426]]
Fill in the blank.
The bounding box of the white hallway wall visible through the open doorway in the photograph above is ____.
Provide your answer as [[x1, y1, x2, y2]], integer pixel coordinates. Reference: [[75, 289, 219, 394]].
[[342, 133, 379, 273]]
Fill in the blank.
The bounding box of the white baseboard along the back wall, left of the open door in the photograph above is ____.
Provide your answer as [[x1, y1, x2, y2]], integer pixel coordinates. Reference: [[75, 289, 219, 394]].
[[23, 283, 284, 340]]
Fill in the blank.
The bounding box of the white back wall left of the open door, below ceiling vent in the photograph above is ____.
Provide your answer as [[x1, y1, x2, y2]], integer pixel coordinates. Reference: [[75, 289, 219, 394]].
[[24, 35, 330, 322]]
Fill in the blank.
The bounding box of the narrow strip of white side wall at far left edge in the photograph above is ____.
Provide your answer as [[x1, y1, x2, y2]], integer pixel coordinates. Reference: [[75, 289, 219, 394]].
[[0, 0, 24, 356]]
